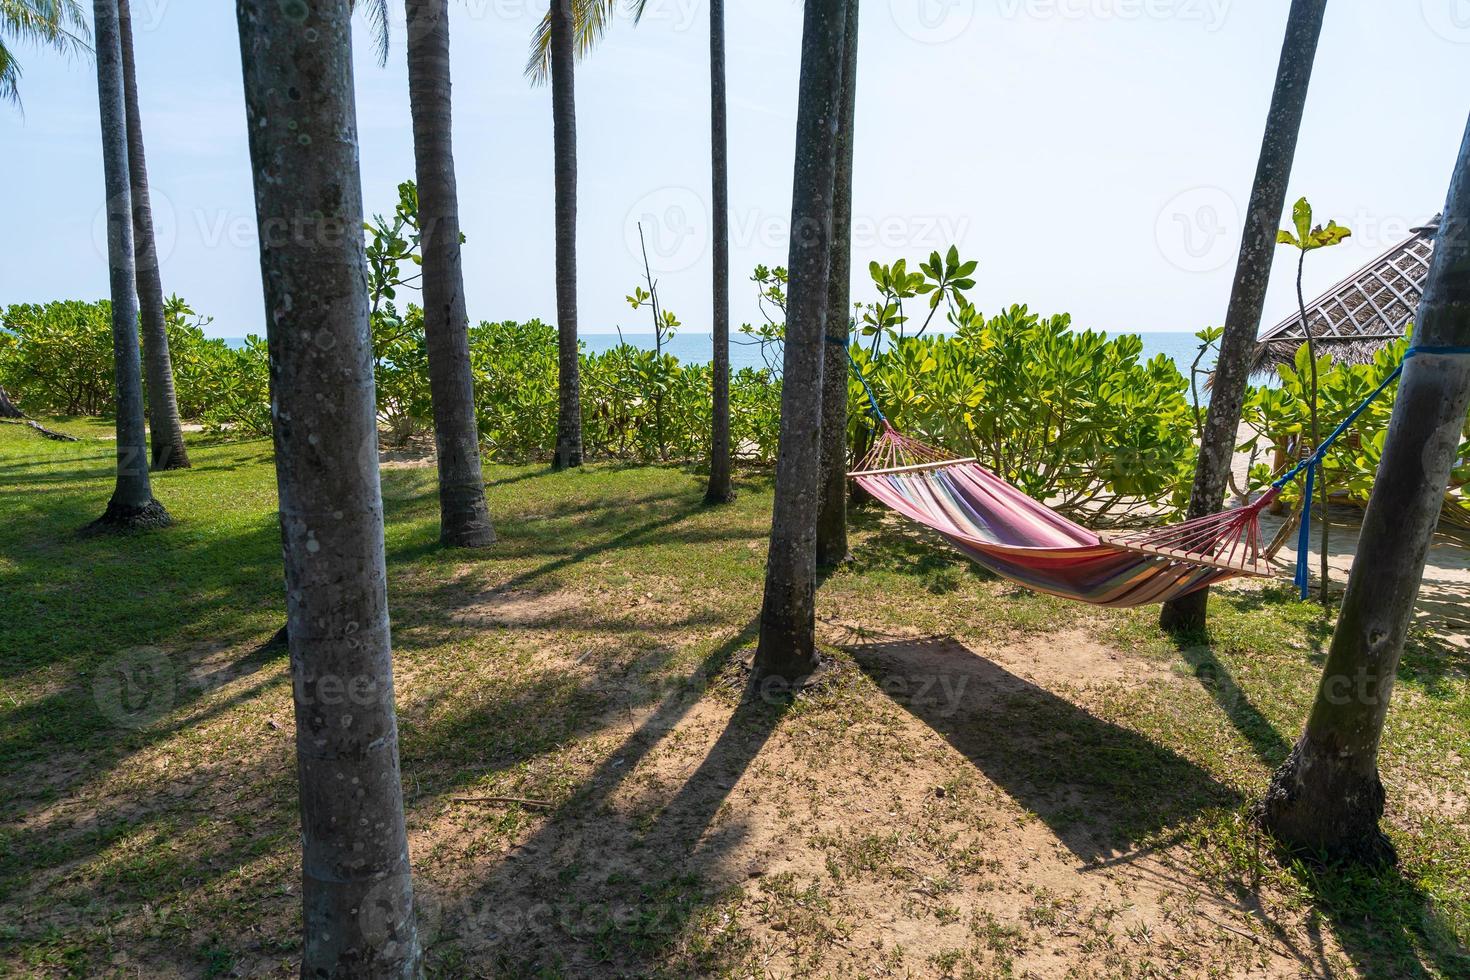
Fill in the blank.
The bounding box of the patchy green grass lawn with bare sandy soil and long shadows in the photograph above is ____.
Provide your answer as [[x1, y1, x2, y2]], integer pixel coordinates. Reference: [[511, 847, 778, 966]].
[[0, 420, 1470, 977]]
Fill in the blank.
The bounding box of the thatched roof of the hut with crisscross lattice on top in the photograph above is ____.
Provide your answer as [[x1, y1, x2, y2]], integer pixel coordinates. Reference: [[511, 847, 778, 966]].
[[1251, 215, 1439, 373]]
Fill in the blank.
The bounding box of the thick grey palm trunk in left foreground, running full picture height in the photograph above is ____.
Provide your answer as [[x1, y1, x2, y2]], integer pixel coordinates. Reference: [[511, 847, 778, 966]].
[[237, 0, 420, 977]]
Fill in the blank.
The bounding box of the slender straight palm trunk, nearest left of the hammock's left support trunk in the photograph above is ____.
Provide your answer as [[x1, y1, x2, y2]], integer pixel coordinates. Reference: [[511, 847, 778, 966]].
[[704, 0, 735, 504]]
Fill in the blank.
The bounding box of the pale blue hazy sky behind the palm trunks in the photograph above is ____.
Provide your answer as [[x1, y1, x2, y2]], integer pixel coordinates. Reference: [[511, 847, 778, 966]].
[[0, 0, 1470, 336]]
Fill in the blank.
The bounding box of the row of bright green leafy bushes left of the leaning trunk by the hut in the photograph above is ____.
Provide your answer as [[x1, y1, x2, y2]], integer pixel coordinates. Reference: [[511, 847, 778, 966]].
[[0, 235, 1194, 519]]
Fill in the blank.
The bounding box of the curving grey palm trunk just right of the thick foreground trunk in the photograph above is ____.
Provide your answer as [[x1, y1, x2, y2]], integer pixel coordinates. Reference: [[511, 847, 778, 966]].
[[407, 0, 495, 548]]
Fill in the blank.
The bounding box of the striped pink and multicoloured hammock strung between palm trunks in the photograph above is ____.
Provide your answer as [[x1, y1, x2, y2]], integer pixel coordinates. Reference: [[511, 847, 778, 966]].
[[850, 422, 1277, 607]]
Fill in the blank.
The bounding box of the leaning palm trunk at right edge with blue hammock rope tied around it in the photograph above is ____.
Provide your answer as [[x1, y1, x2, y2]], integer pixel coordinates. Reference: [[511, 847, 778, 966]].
[[1257, 125, 1470, 860]]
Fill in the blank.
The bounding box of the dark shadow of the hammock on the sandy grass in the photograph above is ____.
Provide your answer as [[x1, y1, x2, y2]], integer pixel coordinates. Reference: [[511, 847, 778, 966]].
[[847, 636, 1241, 864]]
